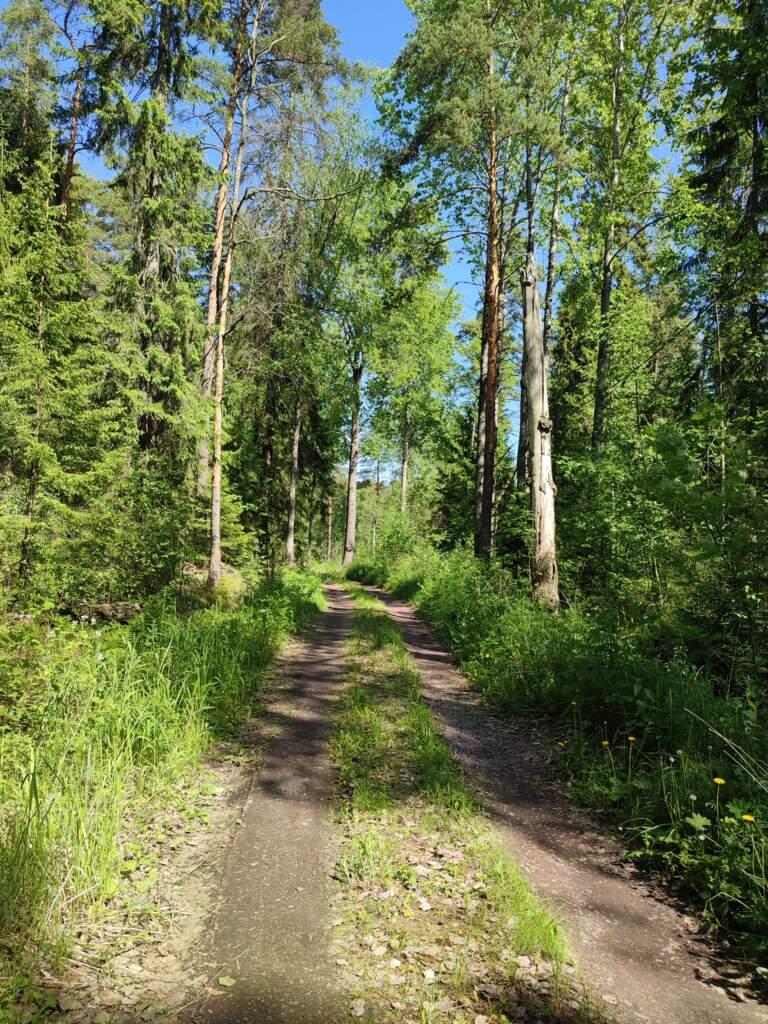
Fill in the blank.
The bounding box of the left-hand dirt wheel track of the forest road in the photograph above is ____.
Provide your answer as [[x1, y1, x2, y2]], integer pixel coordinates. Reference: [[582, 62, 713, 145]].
[[187, 587, 352, 1024]]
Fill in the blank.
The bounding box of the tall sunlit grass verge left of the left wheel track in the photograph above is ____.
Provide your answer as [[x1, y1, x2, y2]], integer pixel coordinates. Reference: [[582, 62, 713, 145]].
[[0, 572, 323, 1007]]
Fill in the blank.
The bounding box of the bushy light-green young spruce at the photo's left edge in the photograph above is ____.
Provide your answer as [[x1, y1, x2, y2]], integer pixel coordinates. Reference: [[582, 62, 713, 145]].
[[0, 149, 125, 604]]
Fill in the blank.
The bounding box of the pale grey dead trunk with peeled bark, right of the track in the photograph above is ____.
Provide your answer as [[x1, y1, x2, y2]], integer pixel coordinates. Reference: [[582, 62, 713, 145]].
[[520, 252, 560, 610]]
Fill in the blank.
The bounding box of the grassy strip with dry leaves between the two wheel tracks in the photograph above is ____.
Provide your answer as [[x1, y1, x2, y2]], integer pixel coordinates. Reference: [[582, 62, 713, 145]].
[[331, 585, 604, 1024]]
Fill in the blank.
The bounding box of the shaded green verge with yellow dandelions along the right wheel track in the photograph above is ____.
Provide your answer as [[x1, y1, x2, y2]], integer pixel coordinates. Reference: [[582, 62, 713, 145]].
[[350, 549, 768, 962]]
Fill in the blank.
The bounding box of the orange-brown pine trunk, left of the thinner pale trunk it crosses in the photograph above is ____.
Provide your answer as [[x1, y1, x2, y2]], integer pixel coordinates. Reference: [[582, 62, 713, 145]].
[[198, 9, 247, 496]]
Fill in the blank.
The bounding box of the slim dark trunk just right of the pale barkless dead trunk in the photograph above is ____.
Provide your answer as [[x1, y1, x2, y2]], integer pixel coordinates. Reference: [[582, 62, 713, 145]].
[[592, 23, 625, 449]]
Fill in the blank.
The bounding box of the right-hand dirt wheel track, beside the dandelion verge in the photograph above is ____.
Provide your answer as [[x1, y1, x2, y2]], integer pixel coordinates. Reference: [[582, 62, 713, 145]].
[[366, 587, 768, 1024]]
